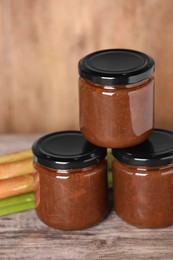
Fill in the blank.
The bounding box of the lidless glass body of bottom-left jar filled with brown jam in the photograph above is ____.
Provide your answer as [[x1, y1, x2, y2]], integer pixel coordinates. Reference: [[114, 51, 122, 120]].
[[34, 160, 108, 230]]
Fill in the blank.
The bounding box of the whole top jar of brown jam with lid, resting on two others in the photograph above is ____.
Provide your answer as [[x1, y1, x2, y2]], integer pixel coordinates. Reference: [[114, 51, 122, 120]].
[[79, 49, 154, 148]]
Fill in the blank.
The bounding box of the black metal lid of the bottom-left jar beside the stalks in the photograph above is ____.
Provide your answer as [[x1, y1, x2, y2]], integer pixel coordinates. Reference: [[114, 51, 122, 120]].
[[32, 131, 106, 169]]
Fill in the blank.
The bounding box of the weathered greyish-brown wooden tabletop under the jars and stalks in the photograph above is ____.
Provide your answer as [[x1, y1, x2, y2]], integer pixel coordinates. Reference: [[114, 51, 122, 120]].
[[0, 135, 173, 260]]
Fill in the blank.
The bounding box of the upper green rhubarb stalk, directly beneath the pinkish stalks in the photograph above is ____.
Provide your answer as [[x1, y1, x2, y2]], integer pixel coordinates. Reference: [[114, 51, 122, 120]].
[[0, 192, 34, 209]]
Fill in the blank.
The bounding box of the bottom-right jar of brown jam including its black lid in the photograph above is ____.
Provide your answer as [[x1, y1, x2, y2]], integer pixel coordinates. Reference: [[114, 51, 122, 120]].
[[113, 129, 173, 228]]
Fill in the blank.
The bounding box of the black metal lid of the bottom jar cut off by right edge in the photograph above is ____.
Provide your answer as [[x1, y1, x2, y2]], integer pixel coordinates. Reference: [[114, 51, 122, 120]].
[[112, 129, 173, 166]]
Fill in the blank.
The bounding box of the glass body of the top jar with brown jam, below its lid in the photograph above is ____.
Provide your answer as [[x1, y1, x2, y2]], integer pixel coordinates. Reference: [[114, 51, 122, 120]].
[[79, 77, 154, 148]]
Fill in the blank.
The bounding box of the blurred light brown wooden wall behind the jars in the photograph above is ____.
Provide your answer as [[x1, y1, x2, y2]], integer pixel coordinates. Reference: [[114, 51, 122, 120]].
[[0, 0, 173, 133]]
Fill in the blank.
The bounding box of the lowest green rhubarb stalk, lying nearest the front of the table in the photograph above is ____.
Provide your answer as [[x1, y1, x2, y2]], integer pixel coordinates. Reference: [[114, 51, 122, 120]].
[[0, 201, 34, 217]]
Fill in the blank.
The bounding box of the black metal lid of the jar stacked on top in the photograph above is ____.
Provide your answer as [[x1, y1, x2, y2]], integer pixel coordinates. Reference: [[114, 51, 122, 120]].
[[78, 49, 155, 85]]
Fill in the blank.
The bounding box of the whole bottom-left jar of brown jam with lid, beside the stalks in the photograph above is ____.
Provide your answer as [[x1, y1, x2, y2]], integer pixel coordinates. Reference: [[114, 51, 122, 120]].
[[32, 131, 108, 230]]
